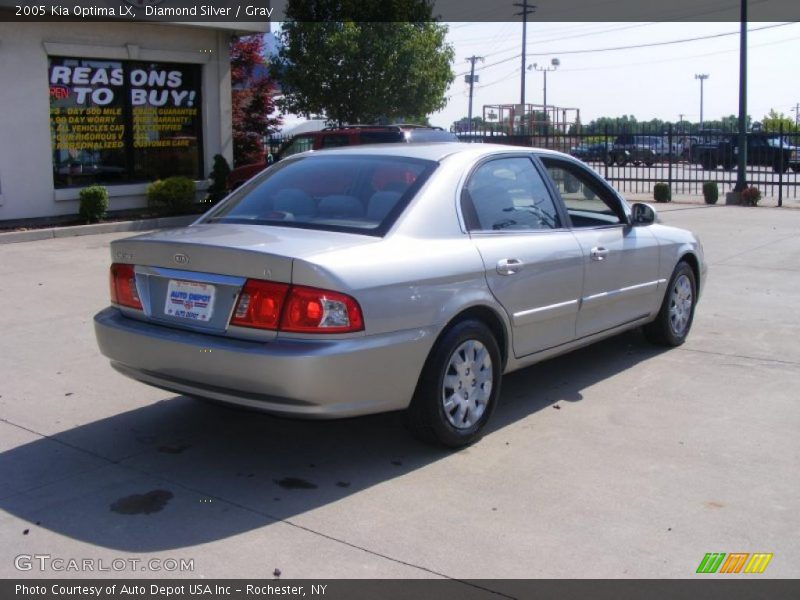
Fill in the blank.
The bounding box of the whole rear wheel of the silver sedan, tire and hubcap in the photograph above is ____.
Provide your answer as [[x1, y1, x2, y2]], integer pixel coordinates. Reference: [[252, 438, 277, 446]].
[[407, 319, 502, 448]]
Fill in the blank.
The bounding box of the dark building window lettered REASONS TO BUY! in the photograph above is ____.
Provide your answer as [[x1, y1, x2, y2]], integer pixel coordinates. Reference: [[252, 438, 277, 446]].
[[48, 57, 203, 188]]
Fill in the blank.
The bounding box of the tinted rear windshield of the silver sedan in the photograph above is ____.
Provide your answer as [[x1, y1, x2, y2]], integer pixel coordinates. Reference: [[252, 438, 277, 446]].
[[201, 153, 437, 235]]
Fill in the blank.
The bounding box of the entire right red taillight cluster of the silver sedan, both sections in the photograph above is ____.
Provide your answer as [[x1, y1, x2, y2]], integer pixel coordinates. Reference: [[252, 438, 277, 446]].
[[225, 279, 364, 333]]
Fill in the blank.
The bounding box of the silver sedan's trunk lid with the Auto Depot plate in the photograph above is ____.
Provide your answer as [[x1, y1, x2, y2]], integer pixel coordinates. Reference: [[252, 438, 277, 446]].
[[111, 224, 376, 339]]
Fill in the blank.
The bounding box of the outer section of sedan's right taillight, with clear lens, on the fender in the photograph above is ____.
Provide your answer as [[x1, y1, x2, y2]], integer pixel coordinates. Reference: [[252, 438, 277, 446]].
[[280, 285, 364, 333]]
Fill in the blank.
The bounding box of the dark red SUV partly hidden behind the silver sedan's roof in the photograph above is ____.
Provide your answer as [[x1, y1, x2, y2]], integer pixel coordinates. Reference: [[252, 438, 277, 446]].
[[228, 125, 458, 190]]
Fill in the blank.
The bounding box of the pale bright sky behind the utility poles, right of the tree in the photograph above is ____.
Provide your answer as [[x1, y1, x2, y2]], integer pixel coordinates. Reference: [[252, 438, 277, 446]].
[[430, 21, 800, 128]]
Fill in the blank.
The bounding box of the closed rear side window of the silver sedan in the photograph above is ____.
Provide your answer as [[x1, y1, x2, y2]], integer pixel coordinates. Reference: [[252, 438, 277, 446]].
[[461, 157, 562, 231]]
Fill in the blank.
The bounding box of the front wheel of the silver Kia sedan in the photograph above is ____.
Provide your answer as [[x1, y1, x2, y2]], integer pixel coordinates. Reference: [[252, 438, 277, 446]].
[[642, 261, 697, 347]]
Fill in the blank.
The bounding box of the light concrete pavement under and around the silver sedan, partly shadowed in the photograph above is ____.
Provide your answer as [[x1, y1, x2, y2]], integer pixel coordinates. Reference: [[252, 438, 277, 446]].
[[0, 204, 800, 578]]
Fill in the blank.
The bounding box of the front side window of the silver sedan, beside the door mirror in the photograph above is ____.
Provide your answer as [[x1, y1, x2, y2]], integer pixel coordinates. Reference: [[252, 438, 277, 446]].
[[540, 156, 627, 228]]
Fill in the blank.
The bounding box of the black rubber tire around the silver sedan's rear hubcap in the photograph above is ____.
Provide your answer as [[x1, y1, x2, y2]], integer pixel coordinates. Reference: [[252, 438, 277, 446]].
[[406, 319, 503, 448]]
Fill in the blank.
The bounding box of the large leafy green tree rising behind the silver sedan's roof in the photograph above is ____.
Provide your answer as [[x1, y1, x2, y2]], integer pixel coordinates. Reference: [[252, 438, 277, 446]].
[[271, 0, 454, 123]]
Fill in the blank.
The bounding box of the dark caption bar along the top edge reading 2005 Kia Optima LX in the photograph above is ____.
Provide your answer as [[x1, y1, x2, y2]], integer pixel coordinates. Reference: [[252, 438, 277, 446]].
[[0, 0, 800, 23]]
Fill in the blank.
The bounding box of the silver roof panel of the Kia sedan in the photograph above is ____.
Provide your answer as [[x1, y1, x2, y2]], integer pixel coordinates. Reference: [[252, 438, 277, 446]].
[[295, 142, 567, 162]]
